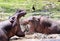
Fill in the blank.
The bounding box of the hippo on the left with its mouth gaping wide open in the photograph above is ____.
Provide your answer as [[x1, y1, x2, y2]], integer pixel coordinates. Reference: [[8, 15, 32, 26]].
[[0, 9, 26, 41]]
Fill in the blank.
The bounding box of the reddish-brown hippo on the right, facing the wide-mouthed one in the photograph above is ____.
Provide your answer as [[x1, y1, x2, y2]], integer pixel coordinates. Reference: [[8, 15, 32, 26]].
[[23, 16, 60, 34]]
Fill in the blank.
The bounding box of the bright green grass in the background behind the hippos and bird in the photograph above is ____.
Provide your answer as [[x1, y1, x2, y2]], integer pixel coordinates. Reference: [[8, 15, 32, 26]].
[[0, 0, 60, 20]]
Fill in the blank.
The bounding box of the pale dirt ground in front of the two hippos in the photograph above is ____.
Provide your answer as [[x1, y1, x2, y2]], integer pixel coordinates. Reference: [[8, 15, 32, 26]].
[[10, 33, 60, 41]]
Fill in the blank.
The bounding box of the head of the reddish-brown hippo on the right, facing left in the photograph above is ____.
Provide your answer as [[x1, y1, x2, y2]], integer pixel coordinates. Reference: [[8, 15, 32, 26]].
[[22, 16, 40, 34]]
